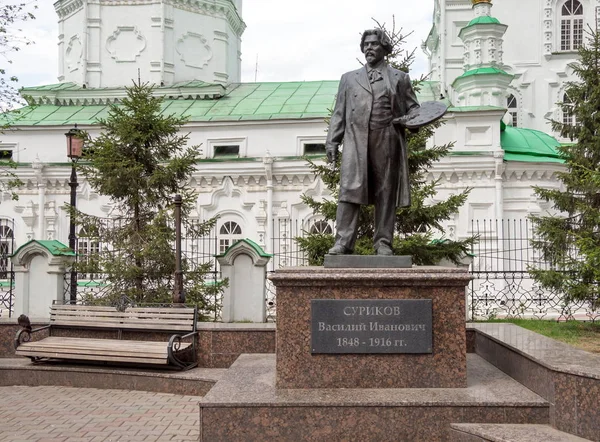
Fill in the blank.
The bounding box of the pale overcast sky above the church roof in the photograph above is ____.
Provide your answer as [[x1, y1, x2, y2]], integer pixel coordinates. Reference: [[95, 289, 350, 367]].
[[8, 0, 433, 86]]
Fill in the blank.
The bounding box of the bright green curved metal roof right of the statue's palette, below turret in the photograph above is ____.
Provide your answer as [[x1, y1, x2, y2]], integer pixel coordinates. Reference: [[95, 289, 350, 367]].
[[500, 126, 564, 163]]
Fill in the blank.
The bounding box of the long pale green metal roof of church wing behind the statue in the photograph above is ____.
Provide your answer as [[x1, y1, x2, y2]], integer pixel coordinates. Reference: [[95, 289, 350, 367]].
[[11, 81, 436, 126]]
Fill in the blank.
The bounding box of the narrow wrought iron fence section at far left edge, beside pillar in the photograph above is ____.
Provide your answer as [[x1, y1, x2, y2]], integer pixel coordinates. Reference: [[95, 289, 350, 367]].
[[0, 218, 15, 318]]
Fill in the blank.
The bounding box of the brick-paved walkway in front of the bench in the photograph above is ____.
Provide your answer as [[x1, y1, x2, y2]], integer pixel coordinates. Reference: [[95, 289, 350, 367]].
[[0, 386, 200, 442]]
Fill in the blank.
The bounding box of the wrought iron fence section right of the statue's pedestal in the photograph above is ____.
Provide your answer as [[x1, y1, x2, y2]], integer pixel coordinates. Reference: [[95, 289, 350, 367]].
[[467, 219, 600, 321]]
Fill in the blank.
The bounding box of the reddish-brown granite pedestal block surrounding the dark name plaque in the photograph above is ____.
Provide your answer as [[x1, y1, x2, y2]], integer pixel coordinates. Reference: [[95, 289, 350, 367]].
[[270, 267, 470, 389]]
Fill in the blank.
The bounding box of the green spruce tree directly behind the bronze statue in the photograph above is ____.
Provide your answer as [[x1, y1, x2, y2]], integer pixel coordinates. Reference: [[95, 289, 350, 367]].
[[297, 22, 476, 265]]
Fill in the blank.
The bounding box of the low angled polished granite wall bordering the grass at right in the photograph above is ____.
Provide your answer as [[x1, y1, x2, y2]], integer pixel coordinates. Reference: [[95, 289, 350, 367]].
[[469, 323, 600, 441]]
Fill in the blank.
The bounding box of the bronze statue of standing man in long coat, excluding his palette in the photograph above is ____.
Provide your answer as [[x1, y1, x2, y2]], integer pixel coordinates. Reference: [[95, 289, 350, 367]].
[[326, 29, 419, 255]]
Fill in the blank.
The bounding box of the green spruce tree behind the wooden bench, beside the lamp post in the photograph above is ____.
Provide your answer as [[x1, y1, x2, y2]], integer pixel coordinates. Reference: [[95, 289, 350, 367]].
[[71, 83, 221, 310]]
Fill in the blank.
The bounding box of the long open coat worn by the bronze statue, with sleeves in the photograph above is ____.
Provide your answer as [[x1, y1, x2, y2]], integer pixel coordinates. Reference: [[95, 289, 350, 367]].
[[327, 65, 419, 207]]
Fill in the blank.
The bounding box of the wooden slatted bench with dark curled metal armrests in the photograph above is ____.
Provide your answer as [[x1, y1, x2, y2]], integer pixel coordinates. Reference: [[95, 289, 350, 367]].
[[15, 305, 197, 369]]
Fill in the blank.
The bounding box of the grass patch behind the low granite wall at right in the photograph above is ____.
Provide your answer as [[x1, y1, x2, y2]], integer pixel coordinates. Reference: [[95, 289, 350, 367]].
[[482, 319, 600, 353]]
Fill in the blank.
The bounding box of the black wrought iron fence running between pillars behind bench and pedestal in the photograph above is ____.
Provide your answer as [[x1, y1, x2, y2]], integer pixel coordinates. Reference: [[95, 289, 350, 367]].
[[58, 218, 600, 321]]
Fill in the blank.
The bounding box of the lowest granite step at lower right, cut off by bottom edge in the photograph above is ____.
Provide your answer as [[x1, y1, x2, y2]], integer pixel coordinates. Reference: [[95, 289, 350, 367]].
[[450, 424, 589, 442]]
